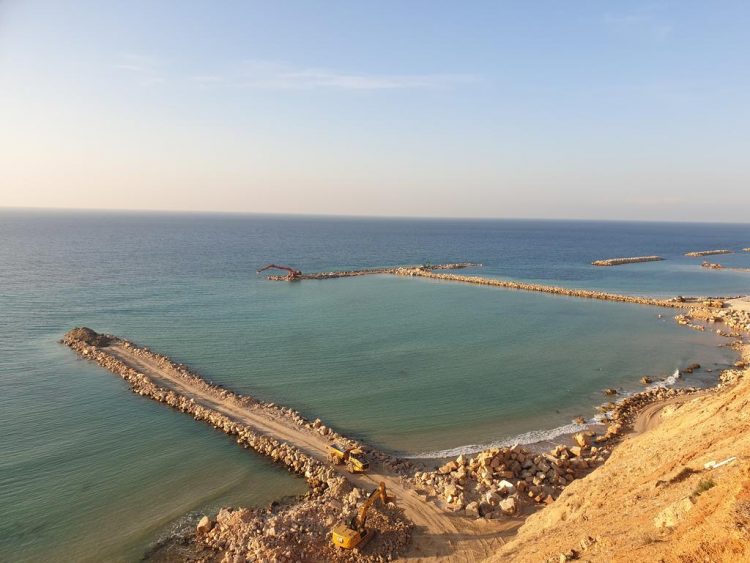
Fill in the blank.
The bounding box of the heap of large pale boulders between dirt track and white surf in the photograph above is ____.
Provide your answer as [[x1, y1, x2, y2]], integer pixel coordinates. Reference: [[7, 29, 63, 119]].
[[414, 432, 609, 519]]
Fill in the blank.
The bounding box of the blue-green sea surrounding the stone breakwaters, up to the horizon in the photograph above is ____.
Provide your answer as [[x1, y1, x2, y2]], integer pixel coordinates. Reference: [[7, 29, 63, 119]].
[[0, 209, 750, 561]]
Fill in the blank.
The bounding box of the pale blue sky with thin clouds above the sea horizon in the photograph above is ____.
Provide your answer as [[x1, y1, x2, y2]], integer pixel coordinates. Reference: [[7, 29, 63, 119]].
[[0, 0, 750, 222]]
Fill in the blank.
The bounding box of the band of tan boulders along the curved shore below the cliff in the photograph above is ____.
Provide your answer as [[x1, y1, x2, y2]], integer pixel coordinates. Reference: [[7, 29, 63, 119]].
[[414, 301, 750, 519]]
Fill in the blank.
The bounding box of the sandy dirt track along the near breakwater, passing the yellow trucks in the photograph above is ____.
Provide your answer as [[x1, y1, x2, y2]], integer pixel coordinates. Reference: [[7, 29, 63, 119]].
[[103, 343, 522, 561]]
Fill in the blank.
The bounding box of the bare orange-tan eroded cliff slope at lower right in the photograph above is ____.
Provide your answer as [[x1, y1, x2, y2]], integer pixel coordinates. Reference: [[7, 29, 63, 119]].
[[494, 303, 750, 562]]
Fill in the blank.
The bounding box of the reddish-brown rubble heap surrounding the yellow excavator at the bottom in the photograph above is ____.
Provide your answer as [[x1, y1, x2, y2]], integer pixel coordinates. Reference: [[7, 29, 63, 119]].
[[195, 482, 412, 563]]
